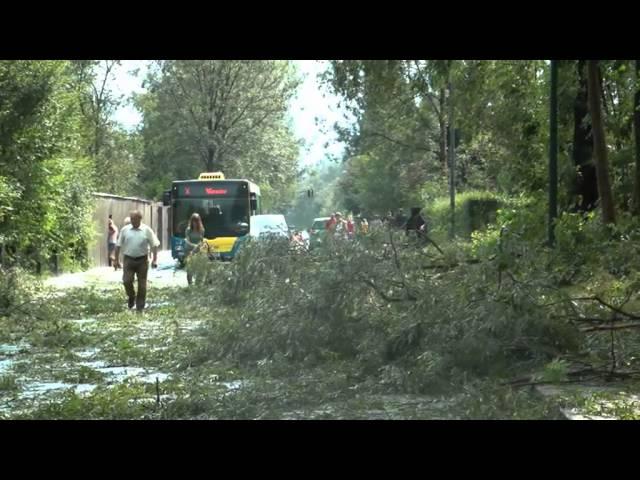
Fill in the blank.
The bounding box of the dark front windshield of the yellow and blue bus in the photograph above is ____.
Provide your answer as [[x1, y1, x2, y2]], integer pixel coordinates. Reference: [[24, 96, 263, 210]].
[[173, 197, 251, 238]]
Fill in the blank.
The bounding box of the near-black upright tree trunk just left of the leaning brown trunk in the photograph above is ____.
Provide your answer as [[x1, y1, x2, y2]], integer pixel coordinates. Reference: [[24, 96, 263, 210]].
[[573, 60, 598, 212]]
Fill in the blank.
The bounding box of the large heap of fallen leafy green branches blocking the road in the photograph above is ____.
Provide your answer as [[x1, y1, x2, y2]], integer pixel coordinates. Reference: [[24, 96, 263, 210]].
[[189, 232, 579, 392]]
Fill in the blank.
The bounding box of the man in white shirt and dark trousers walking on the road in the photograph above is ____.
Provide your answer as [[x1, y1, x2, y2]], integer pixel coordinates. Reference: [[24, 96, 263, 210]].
[[115, 210, 160, 313]]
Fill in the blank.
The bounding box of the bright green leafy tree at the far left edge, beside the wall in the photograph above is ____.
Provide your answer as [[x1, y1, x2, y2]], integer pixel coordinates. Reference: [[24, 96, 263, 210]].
[[0, 61, 94, 265]]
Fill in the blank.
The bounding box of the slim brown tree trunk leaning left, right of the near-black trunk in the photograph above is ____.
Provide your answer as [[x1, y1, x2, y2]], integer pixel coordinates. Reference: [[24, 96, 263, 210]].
[[587, 60, 616, 225]]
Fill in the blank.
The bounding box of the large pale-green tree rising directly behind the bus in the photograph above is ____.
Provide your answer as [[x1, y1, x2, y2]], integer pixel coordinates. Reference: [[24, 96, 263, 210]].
[[137, 60, 299, 202]]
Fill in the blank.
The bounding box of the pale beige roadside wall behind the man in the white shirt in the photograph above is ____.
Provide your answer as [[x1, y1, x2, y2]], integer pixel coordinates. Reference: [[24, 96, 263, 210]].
[[89, 193, 171, 267]]
